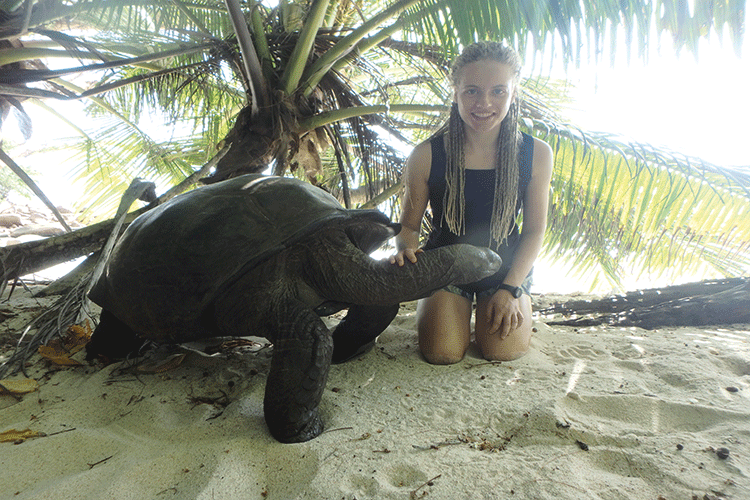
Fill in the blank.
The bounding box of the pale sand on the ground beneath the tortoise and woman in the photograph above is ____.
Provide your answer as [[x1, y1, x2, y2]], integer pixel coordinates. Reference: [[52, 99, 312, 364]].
[[0, 290, 750, 500]]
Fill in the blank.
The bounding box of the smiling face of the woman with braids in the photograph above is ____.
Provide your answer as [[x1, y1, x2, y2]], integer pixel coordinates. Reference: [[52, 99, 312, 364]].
[[454, 60, 515, 139]]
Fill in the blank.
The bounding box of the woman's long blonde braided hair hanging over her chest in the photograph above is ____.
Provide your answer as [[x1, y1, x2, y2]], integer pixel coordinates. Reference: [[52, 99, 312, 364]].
[[440, 42, 521, 248]]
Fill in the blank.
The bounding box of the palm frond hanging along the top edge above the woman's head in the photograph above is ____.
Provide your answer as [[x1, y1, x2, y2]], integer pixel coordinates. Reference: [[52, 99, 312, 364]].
[[407, 0, 745, 63]]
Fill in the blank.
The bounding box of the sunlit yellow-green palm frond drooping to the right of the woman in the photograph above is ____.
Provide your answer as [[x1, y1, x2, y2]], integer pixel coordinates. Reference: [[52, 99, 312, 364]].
[[534, 121, 750, 285]]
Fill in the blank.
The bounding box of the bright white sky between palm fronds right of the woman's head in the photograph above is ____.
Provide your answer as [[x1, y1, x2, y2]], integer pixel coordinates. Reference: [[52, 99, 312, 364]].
[[544, 27, 750, 167]]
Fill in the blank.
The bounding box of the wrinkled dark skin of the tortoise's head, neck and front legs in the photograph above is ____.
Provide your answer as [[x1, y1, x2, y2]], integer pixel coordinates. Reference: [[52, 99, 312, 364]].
[[216, 231, 501, 443]]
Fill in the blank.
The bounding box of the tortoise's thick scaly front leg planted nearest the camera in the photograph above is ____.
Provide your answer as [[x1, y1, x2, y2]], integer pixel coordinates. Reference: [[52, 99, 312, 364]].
[[263, 300, 333, 443]]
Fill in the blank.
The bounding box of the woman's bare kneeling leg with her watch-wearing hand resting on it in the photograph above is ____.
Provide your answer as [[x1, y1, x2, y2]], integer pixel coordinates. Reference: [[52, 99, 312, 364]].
[[475, 294, 531, 361]]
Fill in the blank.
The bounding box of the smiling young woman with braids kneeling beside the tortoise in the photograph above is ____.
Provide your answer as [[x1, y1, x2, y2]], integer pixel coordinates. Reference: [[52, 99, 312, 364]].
[[391, 42, 552, 364]]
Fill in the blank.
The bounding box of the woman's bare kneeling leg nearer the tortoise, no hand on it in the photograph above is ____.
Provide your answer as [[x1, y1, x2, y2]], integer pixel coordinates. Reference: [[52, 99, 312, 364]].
[[417, 290, 471, 365]]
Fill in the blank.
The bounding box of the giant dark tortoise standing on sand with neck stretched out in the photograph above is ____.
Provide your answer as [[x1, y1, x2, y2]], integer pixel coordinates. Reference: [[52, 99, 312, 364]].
[[87, 175, 501, 442]]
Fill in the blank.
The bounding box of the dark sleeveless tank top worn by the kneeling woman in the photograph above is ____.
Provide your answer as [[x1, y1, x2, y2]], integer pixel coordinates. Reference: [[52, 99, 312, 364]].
[[425, 133, 534, 289]]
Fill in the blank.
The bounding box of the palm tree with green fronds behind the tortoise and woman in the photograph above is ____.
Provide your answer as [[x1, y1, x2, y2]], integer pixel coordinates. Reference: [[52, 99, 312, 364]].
[[0, 0, 750, 290]]
